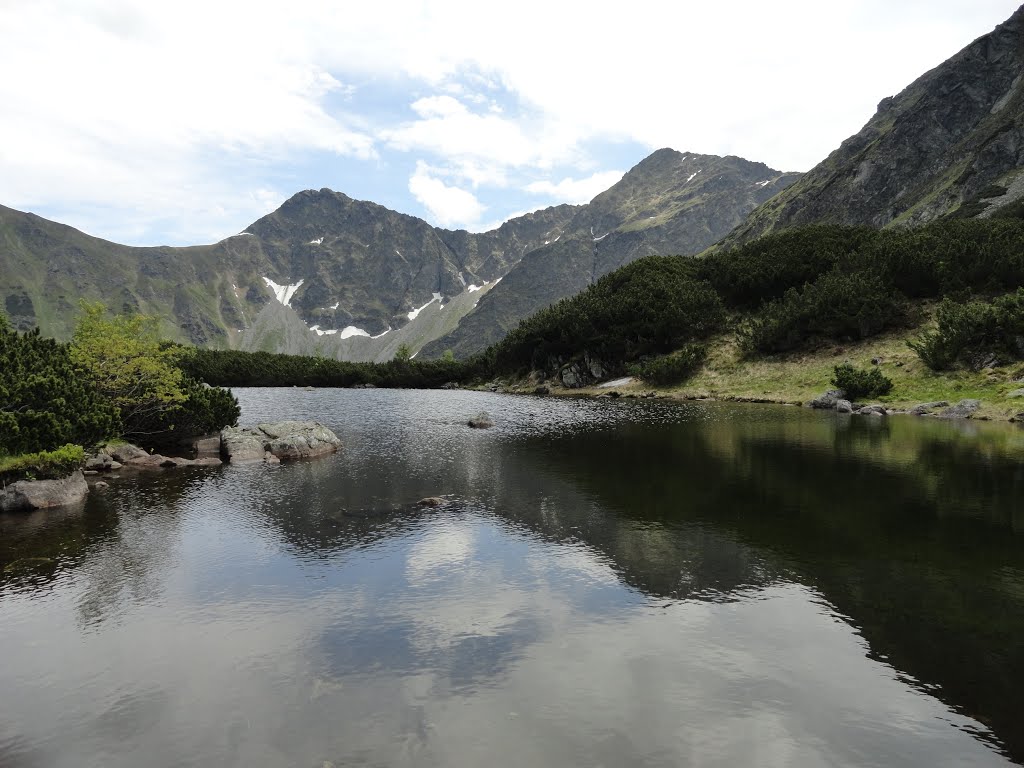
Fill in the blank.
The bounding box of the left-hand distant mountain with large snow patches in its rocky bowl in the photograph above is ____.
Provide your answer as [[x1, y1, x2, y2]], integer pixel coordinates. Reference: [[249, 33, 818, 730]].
[[0, 195, 578, 359]]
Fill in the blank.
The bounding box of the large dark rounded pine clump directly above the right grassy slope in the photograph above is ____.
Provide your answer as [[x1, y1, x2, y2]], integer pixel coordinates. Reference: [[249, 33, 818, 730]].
[[739, 270, 906, 354]]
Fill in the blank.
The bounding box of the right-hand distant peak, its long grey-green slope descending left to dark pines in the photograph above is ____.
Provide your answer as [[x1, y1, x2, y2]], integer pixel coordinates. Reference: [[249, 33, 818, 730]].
[[423, 148, 799, 356]]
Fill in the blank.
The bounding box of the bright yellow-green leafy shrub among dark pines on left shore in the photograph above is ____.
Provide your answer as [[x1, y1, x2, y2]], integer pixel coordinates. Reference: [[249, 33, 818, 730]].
[[71, 301, 186, 437]]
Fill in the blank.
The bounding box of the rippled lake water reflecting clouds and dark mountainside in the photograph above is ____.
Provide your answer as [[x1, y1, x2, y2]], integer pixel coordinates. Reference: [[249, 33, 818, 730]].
[[0, 389, 1024, 768]]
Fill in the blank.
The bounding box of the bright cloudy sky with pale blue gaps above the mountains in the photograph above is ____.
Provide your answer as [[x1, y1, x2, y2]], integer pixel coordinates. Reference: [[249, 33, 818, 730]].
[[0, 0, 1018, 245]]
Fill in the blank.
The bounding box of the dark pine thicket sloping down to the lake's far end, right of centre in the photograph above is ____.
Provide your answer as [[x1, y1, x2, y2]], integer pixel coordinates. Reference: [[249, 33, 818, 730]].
[[486, 256, 725, 374]]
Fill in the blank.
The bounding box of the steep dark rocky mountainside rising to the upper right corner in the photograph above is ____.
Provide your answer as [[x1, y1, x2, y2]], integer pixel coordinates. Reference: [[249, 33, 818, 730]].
[[723, 6, 1024, 246]]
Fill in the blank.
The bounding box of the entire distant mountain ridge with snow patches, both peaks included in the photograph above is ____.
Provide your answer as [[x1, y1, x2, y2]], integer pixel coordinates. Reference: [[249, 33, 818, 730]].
[[0, 150, 796, 360]]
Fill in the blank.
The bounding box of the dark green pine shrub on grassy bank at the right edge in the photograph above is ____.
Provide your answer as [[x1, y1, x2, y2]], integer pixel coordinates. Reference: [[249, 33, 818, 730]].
[[907, 288, 1024, 371]]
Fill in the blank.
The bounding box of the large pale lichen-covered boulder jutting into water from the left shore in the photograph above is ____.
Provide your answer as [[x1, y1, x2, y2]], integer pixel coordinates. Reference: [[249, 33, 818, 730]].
[[220, 421, 341, 464]]
